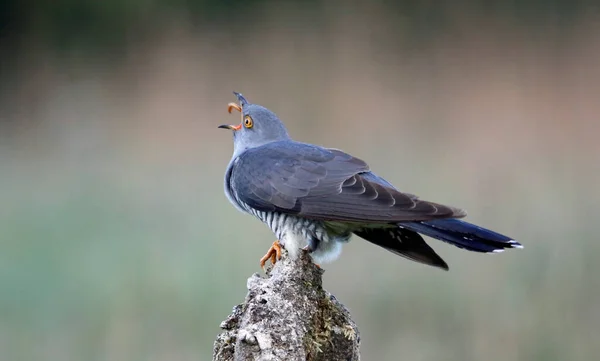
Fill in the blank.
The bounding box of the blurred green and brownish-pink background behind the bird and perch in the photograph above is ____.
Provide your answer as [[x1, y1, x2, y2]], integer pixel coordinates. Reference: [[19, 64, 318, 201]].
[[0, 0, 600, 361]]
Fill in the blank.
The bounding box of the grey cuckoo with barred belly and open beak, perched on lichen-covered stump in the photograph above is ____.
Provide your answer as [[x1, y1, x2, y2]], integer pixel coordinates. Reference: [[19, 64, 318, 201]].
[[219, 92, 523, 270]]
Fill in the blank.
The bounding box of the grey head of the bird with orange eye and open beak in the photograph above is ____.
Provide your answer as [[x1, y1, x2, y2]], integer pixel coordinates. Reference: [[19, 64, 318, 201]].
[[219, 92, 289, 153]]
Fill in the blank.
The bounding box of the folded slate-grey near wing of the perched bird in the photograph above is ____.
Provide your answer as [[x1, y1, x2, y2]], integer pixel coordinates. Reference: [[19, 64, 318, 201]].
[[228, 141, 465, 223]]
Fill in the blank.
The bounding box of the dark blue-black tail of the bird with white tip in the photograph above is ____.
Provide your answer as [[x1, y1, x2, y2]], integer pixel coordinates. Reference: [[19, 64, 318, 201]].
[[399, 219, 523, 253]]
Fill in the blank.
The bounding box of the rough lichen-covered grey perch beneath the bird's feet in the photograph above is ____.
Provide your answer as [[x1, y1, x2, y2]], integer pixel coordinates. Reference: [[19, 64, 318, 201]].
[[213, 251, 360, 361]]
